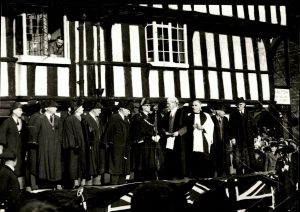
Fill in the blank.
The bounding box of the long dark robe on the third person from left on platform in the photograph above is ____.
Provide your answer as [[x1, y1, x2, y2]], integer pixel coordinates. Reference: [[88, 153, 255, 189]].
[[63, 115, 87, 180]]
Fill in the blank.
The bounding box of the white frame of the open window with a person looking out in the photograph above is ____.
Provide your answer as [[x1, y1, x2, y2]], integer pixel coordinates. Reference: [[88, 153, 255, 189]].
[[14, 12, 71, 65]]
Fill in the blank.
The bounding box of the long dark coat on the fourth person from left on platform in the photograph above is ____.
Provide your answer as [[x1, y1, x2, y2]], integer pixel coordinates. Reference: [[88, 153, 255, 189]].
[[81, 114, 105, 176]]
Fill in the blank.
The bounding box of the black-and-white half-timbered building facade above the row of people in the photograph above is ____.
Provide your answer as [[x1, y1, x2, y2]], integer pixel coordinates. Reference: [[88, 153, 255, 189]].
[[0, 1, 298, 137]]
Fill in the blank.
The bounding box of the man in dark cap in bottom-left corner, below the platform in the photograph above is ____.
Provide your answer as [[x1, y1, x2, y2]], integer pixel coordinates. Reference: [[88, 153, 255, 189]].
[[0, 150, 21, 212]]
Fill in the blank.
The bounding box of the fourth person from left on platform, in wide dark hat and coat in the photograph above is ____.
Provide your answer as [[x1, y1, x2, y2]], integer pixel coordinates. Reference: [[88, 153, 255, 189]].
[[82, 100, 105, 185]]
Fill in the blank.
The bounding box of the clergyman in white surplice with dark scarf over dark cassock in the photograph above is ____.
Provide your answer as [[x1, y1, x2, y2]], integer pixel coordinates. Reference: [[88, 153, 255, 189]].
[[186, 100, 214, 178]]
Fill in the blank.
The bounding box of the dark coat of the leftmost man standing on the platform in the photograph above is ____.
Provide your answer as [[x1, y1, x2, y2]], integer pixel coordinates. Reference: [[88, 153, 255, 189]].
[[0, 117, 27, 177]]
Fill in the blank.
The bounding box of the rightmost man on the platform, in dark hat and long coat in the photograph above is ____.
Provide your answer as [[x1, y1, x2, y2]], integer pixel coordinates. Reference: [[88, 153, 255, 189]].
[[229, 97, 257, 175]]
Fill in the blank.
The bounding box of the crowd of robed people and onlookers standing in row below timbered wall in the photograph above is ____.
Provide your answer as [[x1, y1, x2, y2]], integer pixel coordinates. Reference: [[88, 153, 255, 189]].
[[0, 97, 299, 211]]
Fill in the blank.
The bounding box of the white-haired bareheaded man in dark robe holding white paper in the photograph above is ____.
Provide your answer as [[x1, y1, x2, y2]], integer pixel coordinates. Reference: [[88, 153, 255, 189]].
[[161, 97, 186, 179]]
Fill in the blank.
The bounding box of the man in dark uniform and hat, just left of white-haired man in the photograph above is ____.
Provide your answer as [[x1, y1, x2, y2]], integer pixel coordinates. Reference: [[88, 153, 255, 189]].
[[130, 98, 160, 181]]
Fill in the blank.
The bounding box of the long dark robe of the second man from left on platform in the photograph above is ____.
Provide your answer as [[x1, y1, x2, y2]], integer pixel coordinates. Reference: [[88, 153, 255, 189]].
[[35, 115, 62, 182]]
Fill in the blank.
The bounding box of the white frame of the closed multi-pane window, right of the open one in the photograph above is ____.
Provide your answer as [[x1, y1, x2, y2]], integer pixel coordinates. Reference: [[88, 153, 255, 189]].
[[145, 21, 189, 68]]
